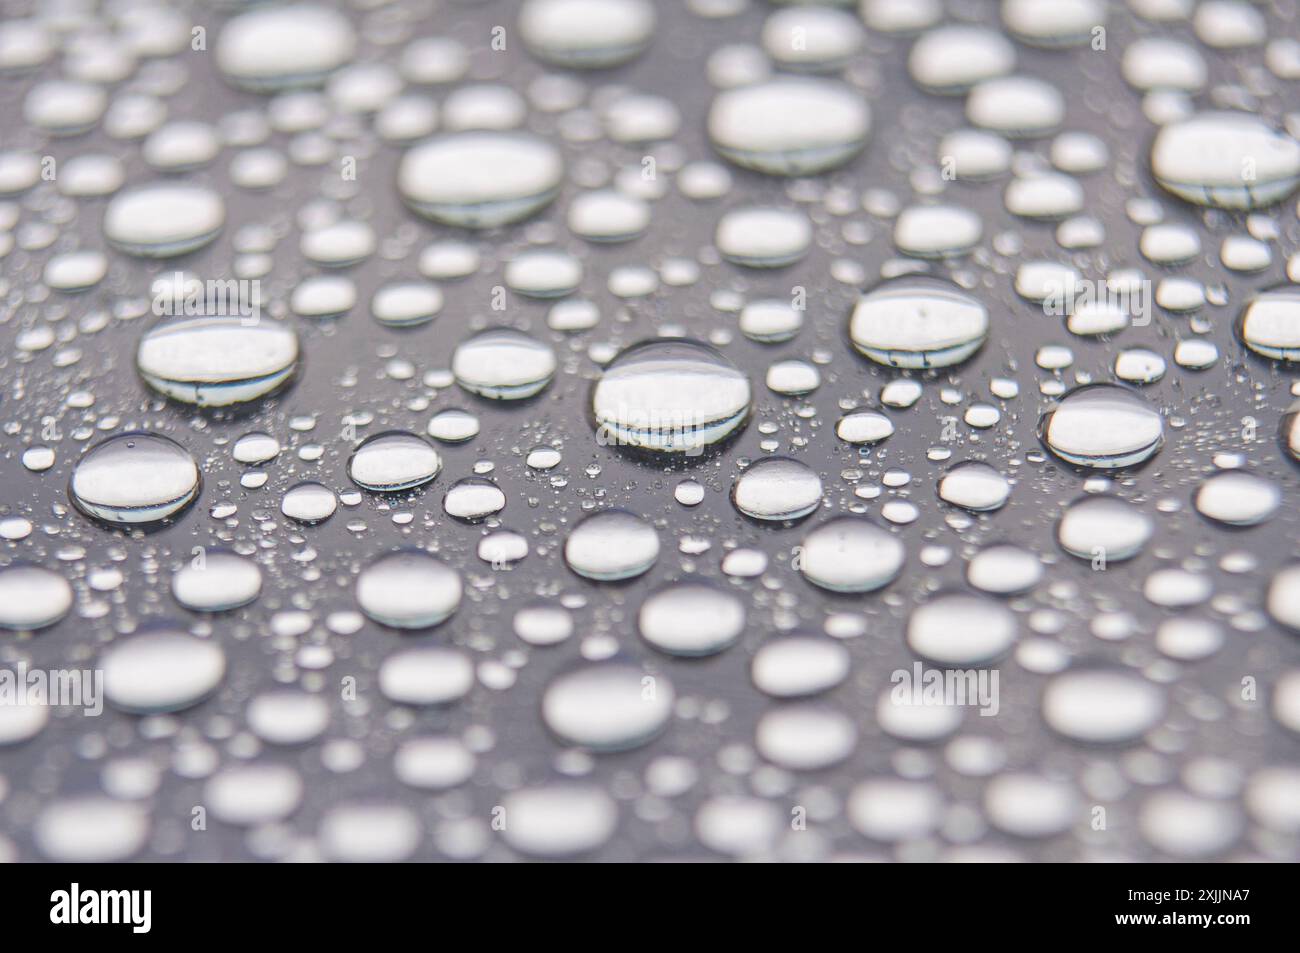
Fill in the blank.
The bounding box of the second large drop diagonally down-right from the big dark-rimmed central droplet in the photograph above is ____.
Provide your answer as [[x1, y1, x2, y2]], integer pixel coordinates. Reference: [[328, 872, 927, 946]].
[[798, 516, 906, 593]]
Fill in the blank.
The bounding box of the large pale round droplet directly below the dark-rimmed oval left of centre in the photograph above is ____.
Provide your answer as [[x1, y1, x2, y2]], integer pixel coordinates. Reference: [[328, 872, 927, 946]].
[[356, 550, 462, 629]]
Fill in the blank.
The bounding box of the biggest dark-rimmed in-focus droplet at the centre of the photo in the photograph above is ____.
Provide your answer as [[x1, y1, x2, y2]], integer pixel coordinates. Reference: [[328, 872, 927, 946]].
[[592, 341, 751, 454]]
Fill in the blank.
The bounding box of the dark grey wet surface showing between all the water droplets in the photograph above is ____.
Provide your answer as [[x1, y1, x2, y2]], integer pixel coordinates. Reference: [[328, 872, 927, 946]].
[[0, 3, 1300, 859]]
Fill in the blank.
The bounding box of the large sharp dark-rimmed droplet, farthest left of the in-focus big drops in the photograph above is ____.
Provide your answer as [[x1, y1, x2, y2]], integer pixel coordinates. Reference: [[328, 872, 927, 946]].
[[68, 430, 200, 528]]
